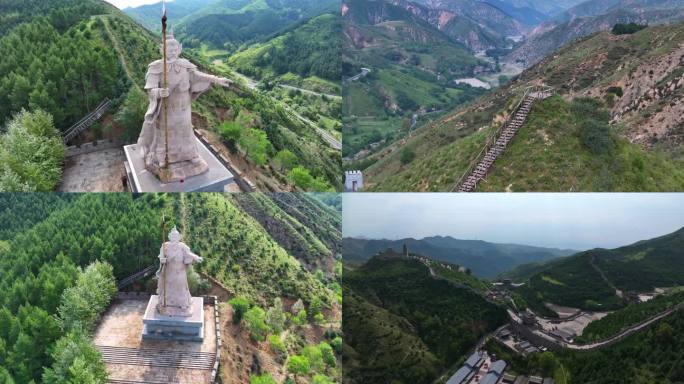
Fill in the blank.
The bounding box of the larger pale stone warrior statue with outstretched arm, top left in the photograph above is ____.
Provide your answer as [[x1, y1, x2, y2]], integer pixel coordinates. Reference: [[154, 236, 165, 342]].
[[138, 33, 231, 183]]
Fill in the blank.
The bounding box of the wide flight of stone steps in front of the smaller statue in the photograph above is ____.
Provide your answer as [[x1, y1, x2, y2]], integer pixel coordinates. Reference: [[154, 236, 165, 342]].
[[97, 345, 216, 370]]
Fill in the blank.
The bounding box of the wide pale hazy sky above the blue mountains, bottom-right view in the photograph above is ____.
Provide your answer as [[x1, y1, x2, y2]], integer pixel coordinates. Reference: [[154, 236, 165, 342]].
[[342, 193, 684, 250]]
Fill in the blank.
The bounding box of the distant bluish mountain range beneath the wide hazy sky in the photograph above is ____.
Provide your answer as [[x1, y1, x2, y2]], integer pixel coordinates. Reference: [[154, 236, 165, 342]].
[[342, 236, 577, 278]]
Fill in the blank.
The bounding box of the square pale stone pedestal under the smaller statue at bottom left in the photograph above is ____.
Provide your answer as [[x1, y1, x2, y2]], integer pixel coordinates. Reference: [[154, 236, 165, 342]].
[[142, 295, 204, 341]]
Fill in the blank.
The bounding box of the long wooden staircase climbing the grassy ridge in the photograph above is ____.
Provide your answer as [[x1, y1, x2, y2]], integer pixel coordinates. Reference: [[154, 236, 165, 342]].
[[454, 86, 553, 192]]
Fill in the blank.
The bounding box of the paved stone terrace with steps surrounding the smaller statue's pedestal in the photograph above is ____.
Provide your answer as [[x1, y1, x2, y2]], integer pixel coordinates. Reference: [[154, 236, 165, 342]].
[[93, 296, 217, 384]]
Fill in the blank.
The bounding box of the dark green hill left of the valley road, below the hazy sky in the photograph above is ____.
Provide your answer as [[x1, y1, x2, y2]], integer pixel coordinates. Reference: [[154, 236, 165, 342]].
[[343, 254, 506, 383]]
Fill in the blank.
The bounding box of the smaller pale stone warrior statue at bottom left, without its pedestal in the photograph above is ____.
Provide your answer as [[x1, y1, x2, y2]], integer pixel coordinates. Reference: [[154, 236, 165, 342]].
[[157, 227, 202, 317]]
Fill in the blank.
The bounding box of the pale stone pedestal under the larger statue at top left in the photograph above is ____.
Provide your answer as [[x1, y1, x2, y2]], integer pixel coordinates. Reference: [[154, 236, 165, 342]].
[[124, 137, 235, 192]]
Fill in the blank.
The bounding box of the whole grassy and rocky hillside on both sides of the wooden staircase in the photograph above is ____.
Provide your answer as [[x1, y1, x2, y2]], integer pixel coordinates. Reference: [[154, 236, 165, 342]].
[[364, 23, 684, 191]]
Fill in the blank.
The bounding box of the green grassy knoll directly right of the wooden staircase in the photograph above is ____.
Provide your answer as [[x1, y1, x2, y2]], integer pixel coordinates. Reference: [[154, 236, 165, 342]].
[[478, 96, 684, 192]]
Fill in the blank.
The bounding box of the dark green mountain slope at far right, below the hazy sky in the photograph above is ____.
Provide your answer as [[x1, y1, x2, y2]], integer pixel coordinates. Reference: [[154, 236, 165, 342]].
[[520, 228, 684, 310]]
